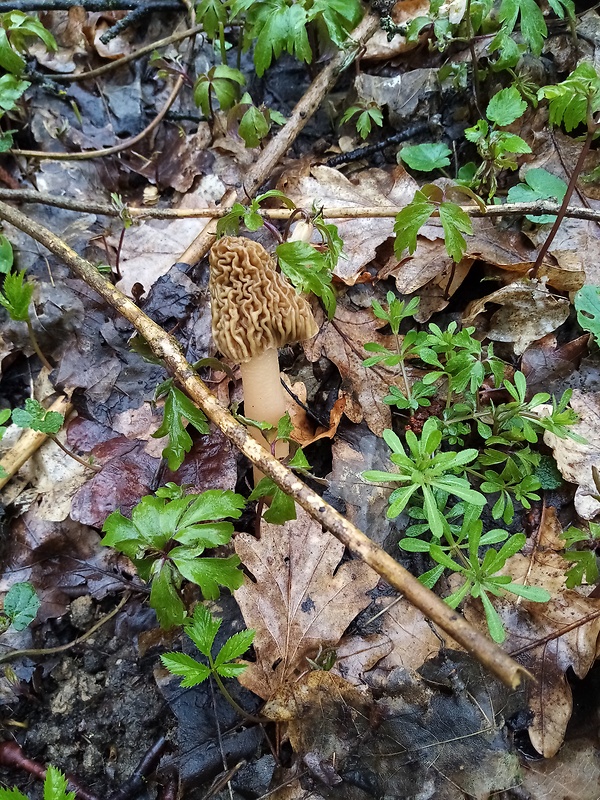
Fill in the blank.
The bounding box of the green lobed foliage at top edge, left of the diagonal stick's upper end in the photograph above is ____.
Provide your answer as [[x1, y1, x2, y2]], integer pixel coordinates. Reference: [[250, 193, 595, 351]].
[[231, 0, 363, 77]]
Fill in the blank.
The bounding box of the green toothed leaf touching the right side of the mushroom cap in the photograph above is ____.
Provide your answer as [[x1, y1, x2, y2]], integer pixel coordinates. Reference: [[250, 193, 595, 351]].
[[275, 242, 336, 319]]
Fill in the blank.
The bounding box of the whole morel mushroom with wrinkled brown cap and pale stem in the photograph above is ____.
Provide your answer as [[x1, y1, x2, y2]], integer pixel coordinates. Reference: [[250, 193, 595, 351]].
[[209, 231, 318, 468]]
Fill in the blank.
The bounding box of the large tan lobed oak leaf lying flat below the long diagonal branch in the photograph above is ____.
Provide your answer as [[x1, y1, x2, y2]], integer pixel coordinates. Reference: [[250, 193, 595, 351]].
[[235, 507, 378, 698]]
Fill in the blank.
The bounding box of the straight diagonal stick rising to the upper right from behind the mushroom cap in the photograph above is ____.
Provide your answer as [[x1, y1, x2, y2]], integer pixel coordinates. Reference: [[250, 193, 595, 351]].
[[179, 14, 379, 264]]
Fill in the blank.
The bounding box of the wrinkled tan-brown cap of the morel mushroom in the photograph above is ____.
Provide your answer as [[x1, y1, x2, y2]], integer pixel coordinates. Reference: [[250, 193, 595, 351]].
[[209, 236, 318, 364]]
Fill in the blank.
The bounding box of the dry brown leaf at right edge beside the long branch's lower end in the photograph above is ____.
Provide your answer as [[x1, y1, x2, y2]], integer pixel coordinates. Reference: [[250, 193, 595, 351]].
[[465, 508, 600, 758]]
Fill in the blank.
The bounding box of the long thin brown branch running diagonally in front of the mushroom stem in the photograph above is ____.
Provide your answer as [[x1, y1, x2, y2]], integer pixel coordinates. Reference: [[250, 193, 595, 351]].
[[0, 202, 527, 686]]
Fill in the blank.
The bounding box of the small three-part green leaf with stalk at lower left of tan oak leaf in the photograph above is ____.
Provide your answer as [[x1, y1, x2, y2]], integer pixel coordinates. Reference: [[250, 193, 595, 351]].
[[160, 603, 254, 717]]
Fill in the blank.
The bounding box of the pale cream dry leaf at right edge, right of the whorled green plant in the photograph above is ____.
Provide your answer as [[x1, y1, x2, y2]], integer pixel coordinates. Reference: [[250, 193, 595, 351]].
[[544, 389, 600, 519]]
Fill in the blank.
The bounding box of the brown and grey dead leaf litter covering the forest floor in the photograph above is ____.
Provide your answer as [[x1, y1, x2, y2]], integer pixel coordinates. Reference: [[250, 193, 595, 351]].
[[0, 3, 600, 800]]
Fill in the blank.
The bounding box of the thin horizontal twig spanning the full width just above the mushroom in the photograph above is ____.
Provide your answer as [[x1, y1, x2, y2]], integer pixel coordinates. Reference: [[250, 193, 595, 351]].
[[0, 189, 600, 222]]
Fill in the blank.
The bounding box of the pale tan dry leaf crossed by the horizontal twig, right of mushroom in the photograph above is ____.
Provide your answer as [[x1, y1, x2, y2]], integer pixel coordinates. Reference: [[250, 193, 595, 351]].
[[278, 166, 422, 285]]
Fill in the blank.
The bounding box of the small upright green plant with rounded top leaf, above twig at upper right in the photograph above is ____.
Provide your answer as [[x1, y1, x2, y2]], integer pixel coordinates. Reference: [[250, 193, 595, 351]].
[[465, 86, 531, 200]]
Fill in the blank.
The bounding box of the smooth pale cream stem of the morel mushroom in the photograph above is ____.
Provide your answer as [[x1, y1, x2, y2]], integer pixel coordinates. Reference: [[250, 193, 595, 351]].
[[240, 347, 290, 484]]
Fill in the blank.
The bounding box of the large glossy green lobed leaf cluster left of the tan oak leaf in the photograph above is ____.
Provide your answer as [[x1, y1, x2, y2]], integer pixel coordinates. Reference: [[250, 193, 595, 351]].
[[102, 484, 246, 628]]
